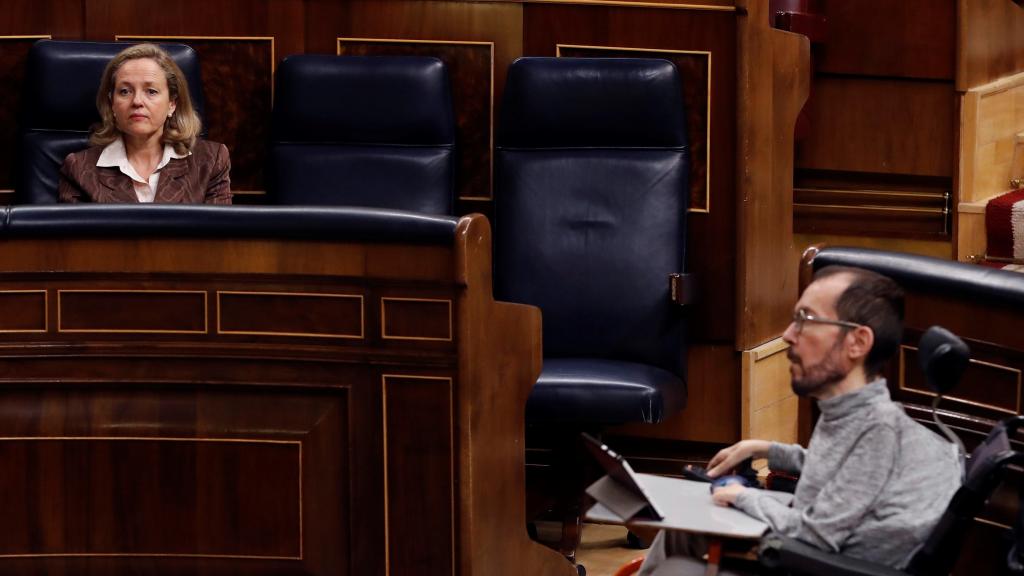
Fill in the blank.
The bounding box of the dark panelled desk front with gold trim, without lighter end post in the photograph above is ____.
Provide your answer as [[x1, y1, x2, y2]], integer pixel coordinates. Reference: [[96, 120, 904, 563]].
[[0, 273, 460, 576]]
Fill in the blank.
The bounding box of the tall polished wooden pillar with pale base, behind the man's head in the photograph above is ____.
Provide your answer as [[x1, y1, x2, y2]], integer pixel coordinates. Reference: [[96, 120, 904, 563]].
[[736, 0, 810, 442]]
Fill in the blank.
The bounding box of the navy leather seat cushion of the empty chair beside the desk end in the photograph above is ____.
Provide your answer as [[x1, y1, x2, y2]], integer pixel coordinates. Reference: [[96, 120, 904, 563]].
[[526, 358, 686, 424]]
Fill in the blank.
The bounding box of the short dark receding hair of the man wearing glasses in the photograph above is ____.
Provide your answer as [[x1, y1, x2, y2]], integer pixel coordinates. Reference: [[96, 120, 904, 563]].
[[814, 265, 903, 377]]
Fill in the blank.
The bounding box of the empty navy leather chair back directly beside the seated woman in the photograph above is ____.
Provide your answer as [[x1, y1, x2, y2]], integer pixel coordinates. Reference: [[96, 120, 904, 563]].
[[269, 54, 456, 214]]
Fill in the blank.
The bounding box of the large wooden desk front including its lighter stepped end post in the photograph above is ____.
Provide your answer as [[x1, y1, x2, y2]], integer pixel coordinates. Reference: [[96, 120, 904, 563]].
[[0, 208, 575, 576]]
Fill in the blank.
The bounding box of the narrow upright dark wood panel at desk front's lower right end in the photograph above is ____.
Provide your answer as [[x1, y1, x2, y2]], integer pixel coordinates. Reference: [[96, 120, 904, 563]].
[[384, 374, 456, 576]]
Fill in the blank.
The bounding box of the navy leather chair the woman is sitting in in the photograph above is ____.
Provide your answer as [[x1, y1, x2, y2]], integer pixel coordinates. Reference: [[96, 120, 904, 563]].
[[15, 40, 205, 204]]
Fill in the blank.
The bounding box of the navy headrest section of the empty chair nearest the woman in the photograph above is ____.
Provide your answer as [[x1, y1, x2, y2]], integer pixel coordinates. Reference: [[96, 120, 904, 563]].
[[273, 54, 455, 146]]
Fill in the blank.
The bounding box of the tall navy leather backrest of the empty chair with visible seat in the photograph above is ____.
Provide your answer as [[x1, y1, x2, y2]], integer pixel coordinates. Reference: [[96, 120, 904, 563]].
[[495, 58, 689, 373]]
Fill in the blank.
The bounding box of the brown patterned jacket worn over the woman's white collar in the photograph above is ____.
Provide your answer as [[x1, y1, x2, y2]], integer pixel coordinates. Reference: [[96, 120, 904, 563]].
[[57, 140, 231, 204]]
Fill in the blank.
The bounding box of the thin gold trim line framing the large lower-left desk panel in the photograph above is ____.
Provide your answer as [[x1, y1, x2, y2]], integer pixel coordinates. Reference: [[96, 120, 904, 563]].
[[0, 436, 305, 561]]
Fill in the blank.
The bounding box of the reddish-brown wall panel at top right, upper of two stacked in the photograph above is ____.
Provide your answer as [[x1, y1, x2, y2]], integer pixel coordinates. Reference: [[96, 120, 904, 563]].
[[814, 0, 954, 81]]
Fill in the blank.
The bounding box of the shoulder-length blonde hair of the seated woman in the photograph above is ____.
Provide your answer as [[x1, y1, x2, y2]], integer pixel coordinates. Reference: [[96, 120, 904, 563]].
[[89, 44, 203, 154]]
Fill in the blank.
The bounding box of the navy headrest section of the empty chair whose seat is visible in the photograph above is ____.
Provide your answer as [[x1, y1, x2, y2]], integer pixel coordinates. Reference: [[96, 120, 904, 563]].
[[499, 57, 686, 148]]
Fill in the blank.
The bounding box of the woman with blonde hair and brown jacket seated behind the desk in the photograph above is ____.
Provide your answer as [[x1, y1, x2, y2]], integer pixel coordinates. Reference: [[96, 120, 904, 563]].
[[58, 44, 231, 204]]
